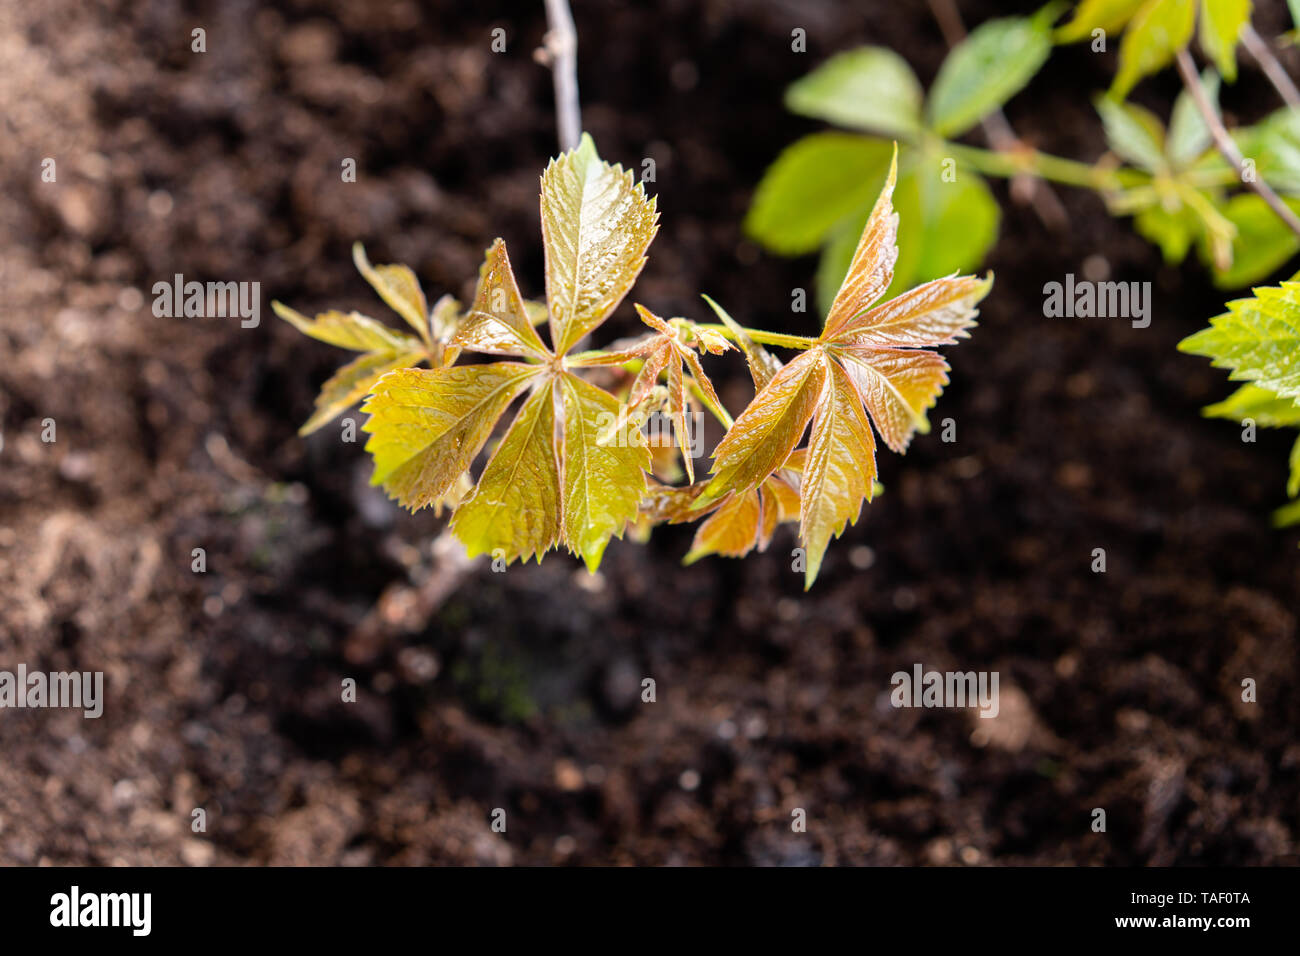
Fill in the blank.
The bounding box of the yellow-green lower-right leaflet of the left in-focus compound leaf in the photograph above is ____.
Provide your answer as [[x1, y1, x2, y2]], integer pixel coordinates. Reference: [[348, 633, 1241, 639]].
[[558, 372, 650, 571]]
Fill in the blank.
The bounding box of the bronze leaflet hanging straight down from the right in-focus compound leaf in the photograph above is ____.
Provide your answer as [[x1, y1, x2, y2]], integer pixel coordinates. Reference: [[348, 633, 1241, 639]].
[[800, 359, 876, 589]]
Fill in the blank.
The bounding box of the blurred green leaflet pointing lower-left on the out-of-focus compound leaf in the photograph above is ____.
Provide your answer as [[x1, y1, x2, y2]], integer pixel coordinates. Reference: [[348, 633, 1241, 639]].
[[745, 133, 893, 255]]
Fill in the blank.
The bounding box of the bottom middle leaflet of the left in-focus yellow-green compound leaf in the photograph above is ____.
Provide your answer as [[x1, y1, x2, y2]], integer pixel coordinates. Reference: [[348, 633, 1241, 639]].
[[451, 382, 560, 563]]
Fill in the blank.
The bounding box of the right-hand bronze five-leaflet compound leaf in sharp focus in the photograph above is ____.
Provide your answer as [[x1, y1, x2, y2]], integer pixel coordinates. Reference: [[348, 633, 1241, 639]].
[[693, 145, 993, 587]]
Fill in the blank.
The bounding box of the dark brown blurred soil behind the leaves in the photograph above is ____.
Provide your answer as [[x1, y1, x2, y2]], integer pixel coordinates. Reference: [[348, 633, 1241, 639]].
[[0, 0, 1300, 865]]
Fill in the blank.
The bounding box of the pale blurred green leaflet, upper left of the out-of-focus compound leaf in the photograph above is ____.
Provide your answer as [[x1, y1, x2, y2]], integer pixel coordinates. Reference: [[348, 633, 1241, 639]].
[[785, 47, 924, 137]]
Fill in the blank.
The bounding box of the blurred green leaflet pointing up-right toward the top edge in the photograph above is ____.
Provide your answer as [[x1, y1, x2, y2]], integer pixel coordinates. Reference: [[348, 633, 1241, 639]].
[[927, 4, 1060, 137]]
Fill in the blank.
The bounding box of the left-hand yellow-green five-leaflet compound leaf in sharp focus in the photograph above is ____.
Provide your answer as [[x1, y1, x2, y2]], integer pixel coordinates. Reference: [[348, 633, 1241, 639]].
[[364, 137, 660, 571]]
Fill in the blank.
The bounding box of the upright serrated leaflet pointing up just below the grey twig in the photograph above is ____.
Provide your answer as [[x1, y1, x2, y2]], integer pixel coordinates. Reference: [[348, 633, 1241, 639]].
[[542, 134, 657, 355]]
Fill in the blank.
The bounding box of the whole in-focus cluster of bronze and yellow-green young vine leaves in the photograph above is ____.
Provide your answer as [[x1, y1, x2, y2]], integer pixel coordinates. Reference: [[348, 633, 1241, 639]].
[[273, 135, 992, 588]]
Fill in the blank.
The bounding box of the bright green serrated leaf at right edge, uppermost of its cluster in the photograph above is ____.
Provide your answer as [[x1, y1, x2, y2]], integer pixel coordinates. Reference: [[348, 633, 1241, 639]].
[[1178, 280, 1300, 399]]
